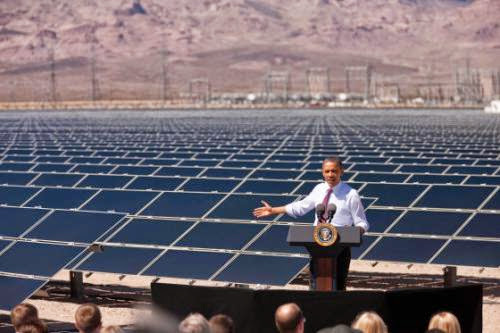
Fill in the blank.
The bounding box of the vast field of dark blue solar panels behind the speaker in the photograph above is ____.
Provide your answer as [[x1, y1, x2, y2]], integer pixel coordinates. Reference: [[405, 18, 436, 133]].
[[0, 110, 500, 309]]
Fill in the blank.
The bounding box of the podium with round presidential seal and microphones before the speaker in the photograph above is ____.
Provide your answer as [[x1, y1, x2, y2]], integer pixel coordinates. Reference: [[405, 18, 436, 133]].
[[286, 224, 361, 291]]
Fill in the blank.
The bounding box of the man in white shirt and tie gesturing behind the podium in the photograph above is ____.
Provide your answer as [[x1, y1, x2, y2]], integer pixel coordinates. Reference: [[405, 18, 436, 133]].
[[253, 156, 369, 290]]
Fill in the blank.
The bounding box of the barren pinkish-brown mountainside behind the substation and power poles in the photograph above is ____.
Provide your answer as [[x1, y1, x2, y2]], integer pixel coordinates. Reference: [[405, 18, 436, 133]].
[[0, 0, 500, 101]]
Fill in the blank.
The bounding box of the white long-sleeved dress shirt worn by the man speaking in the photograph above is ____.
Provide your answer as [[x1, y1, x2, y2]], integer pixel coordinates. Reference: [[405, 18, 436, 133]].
[[285, 182, 370, 231]]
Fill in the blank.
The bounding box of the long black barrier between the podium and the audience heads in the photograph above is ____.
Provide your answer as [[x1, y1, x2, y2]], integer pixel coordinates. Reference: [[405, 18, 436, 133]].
[[151, 283, 483, 333]]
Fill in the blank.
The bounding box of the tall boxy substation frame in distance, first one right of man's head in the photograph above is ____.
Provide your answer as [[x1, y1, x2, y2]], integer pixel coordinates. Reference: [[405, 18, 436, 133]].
[[345, 65, 373, 101]]
